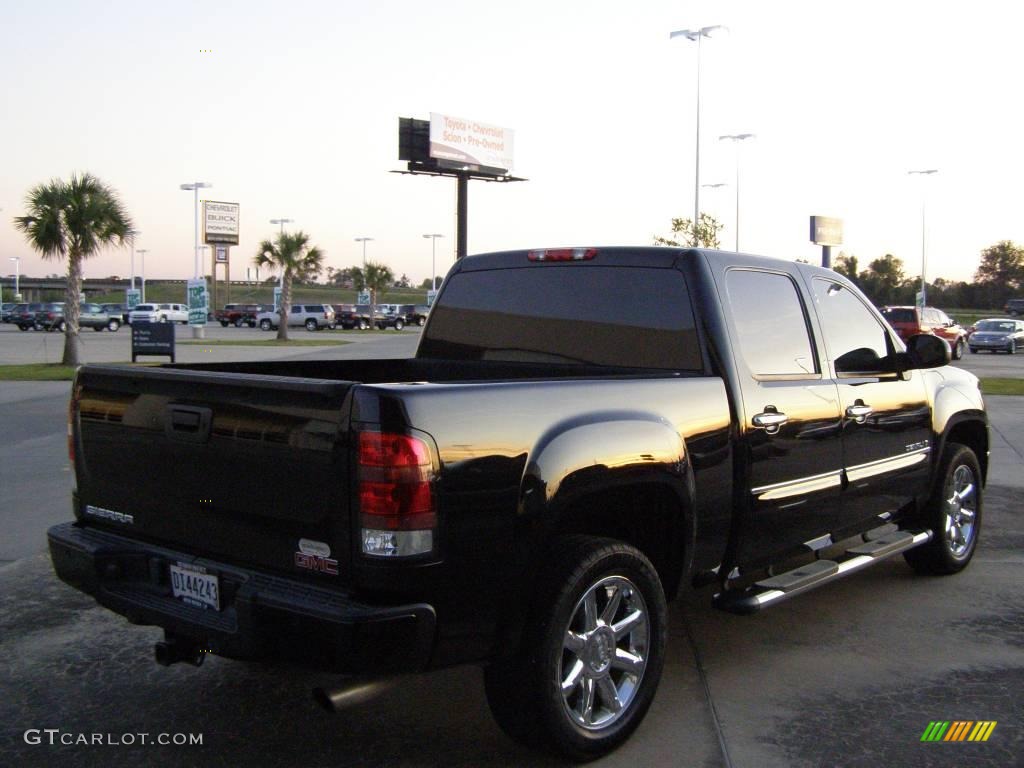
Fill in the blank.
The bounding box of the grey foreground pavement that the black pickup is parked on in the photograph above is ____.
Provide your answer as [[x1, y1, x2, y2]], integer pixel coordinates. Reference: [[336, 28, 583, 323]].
[[0, 337, 1024, 768]]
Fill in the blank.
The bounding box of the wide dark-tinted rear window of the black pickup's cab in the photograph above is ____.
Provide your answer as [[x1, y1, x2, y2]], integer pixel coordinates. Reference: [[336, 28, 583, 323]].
[[418, 265, 701, 371]]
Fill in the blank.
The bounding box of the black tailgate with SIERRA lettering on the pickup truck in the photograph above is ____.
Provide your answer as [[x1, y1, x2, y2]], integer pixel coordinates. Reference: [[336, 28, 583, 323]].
[[73, 366, 354, 579]]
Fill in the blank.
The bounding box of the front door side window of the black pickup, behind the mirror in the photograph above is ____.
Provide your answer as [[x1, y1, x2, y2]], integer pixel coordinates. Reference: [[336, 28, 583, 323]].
[[813, 278, 891, 373]]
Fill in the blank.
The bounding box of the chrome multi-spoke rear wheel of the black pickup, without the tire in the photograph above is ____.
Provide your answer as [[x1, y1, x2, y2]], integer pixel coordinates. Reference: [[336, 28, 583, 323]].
[[557, 575, 650, 730]]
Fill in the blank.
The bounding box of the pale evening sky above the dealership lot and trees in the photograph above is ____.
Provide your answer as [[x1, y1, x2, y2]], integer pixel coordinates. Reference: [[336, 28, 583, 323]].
[[0, 0, 1024, 284]]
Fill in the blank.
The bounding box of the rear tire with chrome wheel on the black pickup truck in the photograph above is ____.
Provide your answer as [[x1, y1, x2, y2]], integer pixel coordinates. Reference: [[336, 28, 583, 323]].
[[484, 537, 668, 760]]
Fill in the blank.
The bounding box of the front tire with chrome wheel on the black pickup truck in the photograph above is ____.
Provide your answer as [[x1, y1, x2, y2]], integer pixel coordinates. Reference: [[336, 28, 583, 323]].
[[903, 442, 982, 575]]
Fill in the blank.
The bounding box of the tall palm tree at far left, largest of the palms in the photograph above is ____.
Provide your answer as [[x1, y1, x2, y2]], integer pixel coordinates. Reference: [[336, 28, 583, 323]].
[[14, 173, 132, 366]]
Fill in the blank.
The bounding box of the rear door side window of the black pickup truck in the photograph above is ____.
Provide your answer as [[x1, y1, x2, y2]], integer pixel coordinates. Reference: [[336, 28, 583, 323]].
[[726, 269, 817, 377]]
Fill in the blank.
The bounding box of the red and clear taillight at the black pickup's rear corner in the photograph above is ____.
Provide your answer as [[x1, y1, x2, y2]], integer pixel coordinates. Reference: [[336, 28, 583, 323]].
[[358, 432, 437, 556]]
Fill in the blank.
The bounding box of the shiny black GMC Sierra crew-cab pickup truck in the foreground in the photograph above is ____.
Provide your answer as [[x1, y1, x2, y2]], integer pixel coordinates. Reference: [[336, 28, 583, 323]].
[[49, 248, 989, 760]]
